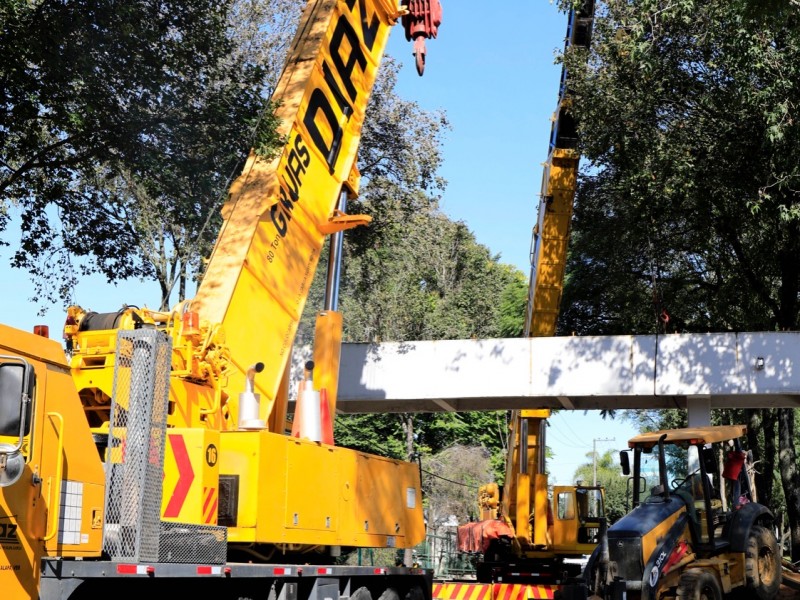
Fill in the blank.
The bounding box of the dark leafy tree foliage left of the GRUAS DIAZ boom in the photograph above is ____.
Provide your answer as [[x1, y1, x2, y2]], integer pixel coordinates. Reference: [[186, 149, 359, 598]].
[[0, 0, 297, 306]]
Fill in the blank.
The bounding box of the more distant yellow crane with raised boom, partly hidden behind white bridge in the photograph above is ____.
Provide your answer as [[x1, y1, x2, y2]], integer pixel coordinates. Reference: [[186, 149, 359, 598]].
[[459, 0, 603, 585]]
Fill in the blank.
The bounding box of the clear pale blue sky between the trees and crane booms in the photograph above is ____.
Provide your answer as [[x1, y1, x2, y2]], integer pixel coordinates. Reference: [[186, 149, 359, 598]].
[[0, 0, 635, 484]]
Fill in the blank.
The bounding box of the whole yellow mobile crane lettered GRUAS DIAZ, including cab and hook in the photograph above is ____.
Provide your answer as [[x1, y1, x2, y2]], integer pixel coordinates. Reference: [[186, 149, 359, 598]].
[[0, 0, 441, 600]]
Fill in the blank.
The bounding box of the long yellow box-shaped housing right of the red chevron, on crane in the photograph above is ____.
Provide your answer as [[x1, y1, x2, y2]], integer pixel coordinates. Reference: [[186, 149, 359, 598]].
[[220, 431, 425, 547]]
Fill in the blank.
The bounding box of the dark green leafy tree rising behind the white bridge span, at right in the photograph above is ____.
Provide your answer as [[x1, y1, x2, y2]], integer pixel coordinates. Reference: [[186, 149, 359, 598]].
[[561, 0, 800, 559]]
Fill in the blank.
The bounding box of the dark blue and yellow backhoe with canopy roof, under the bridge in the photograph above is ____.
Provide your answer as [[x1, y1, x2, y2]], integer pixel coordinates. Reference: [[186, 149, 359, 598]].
[[563, 425, 781, 600]]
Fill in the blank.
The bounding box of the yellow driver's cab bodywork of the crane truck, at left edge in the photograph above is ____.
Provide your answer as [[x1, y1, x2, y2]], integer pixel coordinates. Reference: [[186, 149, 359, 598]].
[[0, 326, 105, 598]]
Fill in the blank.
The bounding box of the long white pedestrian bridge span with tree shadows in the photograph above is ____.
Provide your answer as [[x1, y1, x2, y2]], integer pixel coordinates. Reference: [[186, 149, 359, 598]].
[[328, 332, 800, 420]]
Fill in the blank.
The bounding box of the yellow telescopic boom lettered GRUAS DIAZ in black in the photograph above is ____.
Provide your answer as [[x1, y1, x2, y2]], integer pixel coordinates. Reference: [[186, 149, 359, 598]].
[[191, 0, 400, 428]]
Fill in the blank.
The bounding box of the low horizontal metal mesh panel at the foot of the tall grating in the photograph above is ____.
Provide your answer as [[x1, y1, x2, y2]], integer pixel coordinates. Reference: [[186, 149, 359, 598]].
[[158, 521, 228, 565]]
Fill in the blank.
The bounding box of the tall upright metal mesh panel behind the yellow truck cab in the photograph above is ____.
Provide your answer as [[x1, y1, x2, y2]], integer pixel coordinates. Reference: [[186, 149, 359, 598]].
[[103, 329, 172, 562]]
